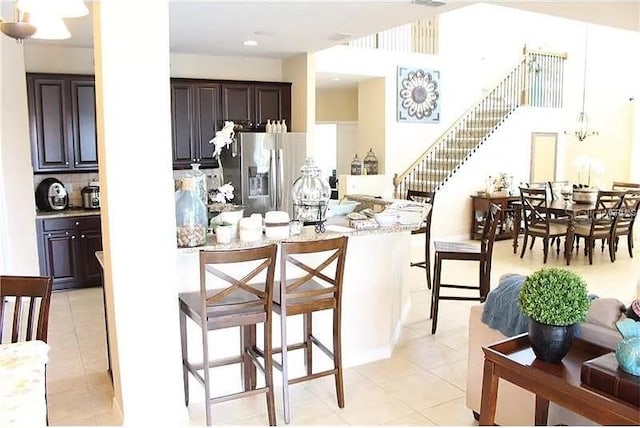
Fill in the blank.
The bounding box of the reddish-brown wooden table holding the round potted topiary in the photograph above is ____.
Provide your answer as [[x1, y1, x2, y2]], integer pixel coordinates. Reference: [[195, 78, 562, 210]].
[[480, 333, 640, 425]]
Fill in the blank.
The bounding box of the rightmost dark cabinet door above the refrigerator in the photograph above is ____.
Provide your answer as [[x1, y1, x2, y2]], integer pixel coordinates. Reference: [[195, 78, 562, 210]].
[[254, 83, 291, 126]]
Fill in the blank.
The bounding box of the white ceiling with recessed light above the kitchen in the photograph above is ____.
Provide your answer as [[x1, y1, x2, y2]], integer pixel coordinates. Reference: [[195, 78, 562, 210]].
[[15, 0, 640, 58]]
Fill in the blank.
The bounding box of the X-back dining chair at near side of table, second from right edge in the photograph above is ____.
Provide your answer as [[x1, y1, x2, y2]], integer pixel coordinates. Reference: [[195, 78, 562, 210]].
[[575, 190, 625, 265]]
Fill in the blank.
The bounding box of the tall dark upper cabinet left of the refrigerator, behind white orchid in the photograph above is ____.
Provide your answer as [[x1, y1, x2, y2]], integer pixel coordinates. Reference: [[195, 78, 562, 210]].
[[171, 79, 221, 169]]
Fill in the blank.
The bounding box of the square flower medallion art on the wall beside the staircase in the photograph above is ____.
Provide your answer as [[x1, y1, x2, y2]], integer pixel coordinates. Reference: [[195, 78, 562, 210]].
[[398, 67, 440, 123]]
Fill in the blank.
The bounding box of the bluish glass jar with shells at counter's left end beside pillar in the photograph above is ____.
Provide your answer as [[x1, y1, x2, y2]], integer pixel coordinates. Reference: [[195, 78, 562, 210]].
[[176, 177, 207, 247]]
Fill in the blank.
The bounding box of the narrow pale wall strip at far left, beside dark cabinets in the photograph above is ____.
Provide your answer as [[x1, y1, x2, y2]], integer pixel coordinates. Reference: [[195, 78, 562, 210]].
[[0, 36, 40, 275]]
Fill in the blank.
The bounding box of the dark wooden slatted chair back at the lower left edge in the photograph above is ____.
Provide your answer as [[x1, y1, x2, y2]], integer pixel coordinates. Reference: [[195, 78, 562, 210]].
[[0, 276, 53, 343]]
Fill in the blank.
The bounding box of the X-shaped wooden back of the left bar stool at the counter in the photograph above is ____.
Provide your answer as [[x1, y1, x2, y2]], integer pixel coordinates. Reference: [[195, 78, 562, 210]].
[[200, 244, 277, 331]]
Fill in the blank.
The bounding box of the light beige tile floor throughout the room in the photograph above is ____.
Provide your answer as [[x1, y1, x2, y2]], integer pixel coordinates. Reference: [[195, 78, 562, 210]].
[[47, 236, 640, 426]]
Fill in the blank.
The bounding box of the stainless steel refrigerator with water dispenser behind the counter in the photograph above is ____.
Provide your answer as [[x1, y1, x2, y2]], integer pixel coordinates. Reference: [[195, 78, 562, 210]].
[[220, 132, 307, 218]]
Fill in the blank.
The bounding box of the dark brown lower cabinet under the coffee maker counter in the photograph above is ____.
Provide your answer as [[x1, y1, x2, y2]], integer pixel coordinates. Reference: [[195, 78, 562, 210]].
[[36, 215, 102, 290]]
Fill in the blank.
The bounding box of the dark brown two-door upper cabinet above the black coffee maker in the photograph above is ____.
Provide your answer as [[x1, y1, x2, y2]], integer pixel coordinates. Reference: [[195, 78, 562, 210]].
[[27, 73, 98, 173]]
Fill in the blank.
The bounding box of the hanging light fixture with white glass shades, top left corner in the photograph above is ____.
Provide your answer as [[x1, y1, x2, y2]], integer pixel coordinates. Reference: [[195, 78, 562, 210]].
[[0, 0, 89, 43]]
